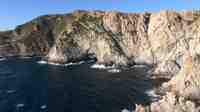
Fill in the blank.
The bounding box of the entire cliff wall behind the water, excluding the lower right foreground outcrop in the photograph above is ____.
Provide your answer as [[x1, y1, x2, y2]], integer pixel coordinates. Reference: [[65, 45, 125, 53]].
[[0, 11, 200, 68]]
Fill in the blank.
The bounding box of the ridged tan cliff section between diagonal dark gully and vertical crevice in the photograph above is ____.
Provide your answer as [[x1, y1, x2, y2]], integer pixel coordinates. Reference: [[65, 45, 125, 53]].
[[103, 12, 153, 64]]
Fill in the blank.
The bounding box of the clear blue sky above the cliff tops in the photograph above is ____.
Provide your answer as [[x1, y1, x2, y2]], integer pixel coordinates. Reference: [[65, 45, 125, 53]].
[[0, 0, 200, 31]]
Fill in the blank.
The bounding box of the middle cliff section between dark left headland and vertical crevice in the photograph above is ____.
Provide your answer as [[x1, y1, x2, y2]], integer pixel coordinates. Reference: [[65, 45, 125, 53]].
[[43, 11, 150, 65]]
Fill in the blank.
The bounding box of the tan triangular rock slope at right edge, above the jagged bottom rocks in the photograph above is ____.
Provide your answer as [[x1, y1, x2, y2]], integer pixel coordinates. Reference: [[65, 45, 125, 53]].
[[163, 56, 200, 100]]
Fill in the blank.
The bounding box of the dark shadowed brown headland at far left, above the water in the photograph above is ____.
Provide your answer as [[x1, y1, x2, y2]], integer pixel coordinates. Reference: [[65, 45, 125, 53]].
[[0, 16, 55, 56]]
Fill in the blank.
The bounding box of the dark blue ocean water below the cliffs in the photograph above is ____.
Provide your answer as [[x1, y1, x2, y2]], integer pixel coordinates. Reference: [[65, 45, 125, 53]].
[[0, 58, 161, 112]]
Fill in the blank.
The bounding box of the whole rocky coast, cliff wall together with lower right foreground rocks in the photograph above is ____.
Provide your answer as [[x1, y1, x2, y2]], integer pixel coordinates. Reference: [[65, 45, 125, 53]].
[[0, 10, 200, 112]]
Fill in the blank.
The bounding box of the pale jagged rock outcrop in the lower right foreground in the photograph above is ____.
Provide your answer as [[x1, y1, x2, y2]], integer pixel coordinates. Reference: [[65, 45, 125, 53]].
[[136, 54, 200, 112]]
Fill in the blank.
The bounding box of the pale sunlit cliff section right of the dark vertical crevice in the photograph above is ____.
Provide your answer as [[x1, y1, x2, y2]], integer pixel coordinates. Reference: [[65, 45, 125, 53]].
[[148, 11, 200, 74]]
